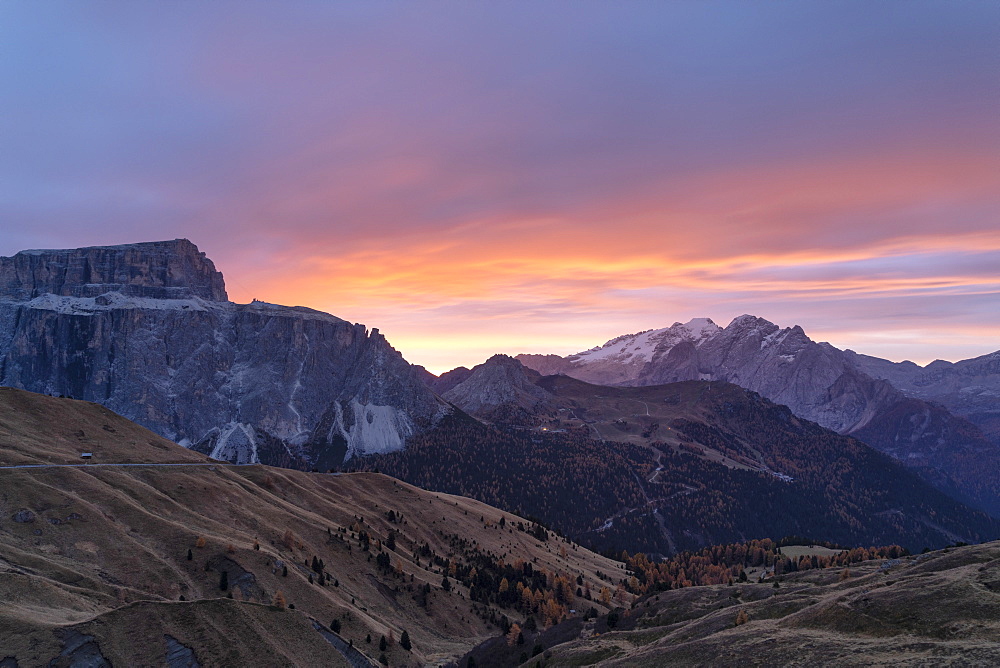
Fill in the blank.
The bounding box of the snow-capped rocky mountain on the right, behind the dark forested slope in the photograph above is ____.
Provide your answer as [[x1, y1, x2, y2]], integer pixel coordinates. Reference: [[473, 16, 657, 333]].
[[517, 315, 1000, 512]]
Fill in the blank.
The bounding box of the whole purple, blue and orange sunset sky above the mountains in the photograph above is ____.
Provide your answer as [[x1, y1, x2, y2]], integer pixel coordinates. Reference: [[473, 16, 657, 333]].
[[0, 0, 1000, 372]]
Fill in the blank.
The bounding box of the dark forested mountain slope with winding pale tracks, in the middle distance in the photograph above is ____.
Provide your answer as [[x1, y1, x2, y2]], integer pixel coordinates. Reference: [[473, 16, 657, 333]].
[[364, 375, 1000, 554]]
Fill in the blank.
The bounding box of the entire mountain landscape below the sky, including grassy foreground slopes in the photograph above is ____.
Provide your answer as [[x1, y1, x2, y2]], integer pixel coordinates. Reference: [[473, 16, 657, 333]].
[[0, 239, 1000, 668]]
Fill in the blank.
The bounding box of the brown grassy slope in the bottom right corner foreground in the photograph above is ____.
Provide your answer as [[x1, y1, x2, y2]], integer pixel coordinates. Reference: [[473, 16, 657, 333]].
[[529, 542, 1000, 667]]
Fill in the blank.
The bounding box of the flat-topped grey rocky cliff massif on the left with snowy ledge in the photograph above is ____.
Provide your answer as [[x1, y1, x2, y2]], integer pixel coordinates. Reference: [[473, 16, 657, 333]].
[[0, 240, 447, 469]]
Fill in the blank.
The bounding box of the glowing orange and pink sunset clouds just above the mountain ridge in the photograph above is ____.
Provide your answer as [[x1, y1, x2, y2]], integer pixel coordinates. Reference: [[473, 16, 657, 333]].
[[205, 131, 1000, 371]]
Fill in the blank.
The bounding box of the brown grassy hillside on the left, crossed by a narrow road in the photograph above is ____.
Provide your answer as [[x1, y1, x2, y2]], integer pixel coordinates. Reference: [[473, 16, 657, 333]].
[[0, 388, 619, 666]]
